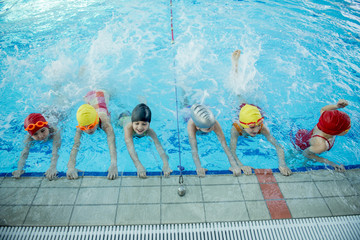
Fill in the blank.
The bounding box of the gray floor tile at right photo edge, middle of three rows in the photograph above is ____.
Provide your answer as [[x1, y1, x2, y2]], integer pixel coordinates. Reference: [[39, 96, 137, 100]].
[[315, 180, 357, 197]]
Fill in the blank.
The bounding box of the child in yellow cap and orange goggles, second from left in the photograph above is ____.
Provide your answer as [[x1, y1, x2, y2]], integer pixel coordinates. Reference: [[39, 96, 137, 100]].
[[66, 90, 118, 180]]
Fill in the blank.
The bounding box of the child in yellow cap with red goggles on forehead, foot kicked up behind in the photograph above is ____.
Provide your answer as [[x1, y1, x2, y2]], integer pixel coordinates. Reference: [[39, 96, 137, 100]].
[[230, 50, 292, 176]]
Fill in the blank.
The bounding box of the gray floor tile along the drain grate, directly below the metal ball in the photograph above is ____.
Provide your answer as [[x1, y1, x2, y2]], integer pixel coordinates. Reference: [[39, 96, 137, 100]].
[[161, 203, 205, 224]]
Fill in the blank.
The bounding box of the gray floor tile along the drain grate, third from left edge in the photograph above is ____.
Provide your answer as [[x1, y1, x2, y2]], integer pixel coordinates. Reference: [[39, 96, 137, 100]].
[[70, 205, 116, 225]]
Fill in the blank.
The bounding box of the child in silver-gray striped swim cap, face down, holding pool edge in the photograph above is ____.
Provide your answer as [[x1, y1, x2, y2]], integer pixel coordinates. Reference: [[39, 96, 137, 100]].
[[187, 104, 241, 177]]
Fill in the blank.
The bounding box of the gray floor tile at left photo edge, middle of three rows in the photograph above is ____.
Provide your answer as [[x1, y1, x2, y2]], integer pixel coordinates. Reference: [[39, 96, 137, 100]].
[[0, 188, 38, 205]]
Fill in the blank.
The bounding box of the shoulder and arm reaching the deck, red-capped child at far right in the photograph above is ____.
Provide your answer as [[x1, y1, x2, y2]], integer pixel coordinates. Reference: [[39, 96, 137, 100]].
[[303, 139, 345, 172]]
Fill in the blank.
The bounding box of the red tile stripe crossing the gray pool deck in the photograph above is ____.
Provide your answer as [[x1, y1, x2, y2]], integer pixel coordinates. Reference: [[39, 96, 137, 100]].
[[255, 169, 291, 219]]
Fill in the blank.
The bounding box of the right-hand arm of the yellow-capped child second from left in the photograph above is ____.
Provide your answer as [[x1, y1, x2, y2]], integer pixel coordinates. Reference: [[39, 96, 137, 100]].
[[101, 116, 119, 180]]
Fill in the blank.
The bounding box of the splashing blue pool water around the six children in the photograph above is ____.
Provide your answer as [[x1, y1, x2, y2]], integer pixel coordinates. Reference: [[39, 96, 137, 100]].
[[0, 0, 360, 173]]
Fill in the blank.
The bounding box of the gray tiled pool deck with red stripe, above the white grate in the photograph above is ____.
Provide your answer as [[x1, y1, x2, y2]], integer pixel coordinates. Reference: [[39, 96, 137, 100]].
[[0, 169, 360, 226]]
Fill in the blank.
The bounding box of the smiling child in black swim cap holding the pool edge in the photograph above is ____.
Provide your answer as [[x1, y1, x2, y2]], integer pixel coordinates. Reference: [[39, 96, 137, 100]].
[[119, 103, 172, 178]]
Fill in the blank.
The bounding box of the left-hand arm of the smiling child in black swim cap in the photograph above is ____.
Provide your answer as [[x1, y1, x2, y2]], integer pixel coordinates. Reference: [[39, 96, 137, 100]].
[[124, 122, 146, 178]]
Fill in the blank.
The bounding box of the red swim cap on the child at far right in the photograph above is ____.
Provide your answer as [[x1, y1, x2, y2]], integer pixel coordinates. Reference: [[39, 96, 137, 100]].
[[317, 110, 351, 135]]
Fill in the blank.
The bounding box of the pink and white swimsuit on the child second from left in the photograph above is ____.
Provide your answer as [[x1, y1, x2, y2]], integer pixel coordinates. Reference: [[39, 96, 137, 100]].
[[84, 90, 110, 116]]
